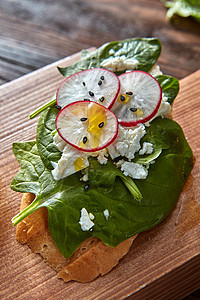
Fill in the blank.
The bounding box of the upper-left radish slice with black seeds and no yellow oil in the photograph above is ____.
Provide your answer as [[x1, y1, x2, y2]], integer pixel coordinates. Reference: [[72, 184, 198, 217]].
[[56, 68, 120, 108]]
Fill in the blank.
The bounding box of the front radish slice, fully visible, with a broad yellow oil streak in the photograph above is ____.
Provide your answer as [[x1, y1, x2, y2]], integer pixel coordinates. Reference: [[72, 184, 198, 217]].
[[56, 101, 118, 152]]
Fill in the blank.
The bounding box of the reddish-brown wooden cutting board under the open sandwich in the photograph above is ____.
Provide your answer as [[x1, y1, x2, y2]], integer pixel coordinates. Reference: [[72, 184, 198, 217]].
[[0, 53, 200, 300]]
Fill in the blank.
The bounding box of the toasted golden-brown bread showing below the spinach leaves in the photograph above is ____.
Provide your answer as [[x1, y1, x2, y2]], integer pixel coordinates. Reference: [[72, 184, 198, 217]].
[[16, 193, 136, 282]]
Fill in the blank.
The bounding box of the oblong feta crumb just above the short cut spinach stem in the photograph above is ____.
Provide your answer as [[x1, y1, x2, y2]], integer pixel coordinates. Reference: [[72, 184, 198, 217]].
[[121, 161, 148, 179]]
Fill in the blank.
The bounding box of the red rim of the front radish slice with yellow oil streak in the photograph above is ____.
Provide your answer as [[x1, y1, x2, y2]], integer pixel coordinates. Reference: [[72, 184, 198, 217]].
[[55, 100, 119, 152]]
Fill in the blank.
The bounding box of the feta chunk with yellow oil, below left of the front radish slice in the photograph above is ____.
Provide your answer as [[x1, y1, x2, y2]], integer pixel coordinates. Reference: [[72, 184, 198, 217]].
[[52, 140, 89, 180]]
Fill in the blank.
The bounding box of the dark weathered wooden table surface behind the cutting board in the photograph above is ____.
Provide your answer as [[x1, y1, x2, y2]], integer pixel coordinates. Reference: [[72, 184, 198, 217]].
[[0, 0, 200, 300]]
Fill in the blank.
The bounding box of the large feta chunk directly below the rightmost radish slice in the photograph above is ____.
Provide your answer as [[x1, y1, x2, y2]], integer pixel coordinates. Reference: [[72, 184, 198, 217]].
[[107, 124, 146, 160]]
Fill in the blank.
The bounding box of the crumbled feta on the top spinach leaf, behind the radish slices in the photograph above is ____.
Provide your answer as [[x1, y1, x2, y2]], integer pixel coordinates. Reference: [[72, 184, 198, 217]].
[[100, 53, 139, 72]]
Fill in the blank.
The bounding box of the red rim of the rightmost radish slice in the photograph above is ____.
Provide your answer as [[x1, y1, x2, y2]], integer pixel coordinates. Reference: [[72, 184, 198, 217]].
[[118, 70, 162, 127]]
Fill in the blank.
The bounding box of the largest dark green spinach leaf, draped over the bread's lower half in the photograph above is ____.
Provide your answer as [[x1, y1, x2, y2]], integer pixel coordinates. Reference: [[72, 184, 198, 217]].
[[11, 118, 193, 257]]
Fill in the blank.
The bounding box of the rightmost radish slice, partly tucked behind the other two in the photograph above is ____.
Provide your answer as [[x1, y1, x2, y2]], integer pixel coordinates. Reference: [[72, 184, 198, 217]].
[[112, 71, 162, 127]]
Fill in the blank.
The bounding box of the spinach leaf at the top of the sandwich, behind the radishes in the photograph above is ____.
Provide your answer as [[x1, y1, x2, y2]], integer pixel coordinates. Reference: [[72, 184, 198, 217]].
[[58, 38, 161, 76]]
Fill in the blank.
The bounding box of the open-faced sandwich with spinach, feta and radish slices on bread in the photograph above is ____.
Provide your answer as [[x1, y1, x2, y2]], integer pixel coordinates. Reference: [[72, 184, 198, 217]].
[[11, 38, 193, 282]]
